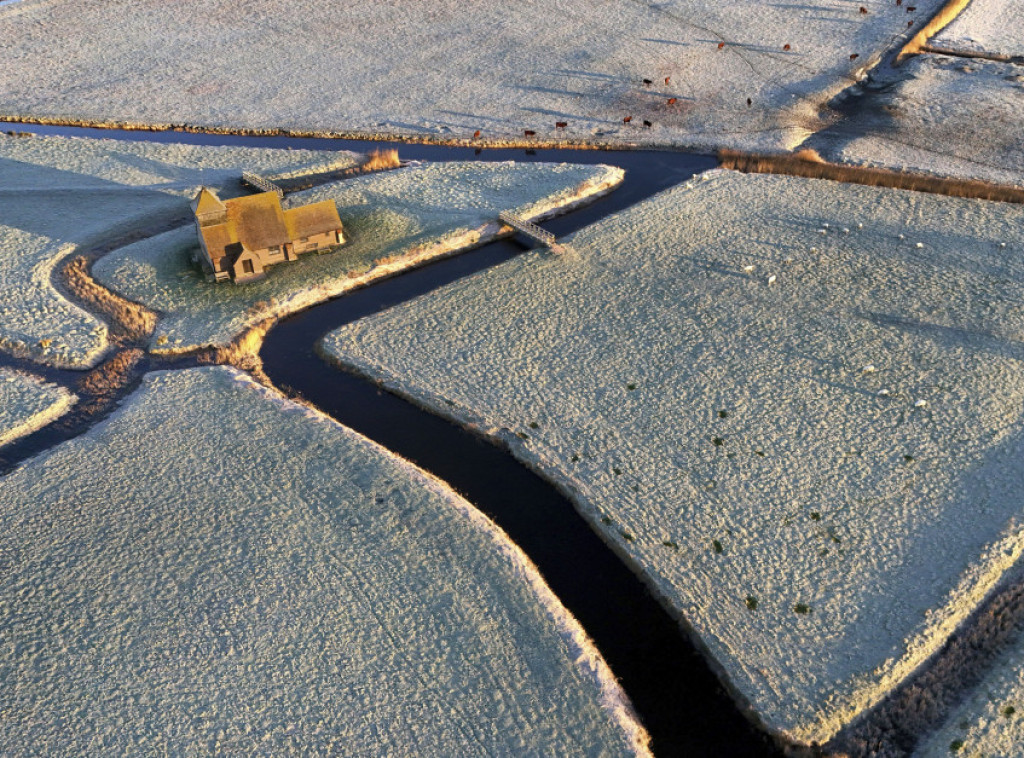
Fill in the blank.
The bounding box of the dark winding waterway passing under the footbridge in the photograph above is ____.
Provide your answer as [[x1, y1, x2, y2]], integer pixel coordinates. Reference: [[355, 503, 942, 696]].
[[5, 124, 778, 757]]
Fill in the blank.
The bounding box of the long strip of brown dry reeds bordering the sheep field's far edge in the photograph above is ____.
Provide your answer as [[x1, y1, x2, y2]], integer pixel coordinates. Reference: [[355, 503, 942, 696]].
[[718, 150, 1024, 203]]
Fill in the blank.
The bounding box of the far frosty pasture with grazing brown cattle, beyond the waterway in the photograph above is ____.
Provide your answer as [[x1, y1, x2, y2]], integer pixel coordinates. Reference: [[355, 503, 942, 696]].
[[0, 0, 942, 150]]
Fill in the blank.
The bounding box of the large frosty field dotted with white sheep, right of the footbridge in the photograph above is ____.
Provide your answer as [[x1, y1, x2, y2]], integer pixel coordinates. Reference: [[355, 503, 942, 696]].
[[324, 171, 1024, 741]]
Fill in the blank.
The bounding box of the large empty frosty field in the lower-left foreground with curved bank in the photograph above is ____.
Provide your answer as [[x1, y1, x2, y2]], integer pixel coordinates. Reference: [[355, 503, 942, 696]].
[[0, 368, 645, 756]]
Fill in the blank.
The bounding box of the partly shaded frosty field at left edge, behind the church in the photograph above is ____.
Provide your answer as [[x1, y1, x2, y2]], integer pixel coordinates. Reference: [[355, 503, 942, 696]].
[[0, 135, 355, 368]]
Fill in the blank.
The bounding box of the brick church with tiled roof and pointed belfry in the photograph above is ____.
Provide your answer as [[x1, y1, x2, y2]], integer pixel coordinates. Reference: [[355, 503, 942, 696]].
[[191, 187, 345, 283]]
